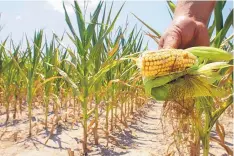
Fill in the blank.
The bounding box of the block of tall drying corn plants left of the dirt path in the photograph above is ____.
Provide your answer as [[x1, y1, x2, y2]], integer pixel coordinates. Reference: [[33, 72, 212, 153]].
[[0, 1, 149, 153]]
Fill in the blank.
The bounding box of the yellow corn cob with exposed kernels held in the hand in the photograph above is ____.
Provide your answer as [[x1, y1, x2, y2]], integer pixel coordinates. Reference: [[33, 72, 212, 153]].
[[137, 49, 197, 77]]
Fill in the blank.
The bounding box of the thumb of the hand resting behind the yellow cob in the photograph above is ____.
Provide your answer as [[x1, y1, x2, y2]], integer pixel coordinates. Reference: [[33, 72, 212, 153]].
[[163, 32, 181, 49]]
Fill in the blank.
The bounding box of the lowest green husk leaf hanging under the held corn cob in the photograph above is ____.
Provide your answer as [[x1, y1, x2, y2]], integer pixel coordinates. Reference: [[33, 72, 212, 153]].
[[149, 75, 227, 101]]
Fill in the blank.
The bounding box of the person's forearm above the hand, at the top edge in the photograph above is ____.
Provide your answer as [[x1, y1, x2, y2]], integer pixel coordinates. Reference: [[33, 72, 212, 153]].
[[174, 0, 215, 25]]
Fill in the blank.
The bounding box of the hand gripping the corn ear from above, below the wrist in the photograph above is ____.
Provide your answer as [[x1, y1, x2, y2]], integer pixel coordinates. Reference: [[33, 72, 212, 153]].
[[159, 16, 209, 49]]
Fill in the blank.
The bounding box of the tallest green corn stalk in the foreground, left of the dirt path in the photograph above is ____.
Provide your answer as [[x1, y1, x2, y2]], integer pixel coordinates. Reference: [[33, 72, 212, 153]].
[[64, 2, 125, 153]]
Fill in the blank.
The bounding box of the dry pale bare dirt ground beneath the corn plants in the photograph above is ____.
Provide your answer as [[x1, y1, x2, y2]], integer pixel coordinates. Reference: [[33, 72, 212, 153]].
[[0, 103, 233, 156]]
